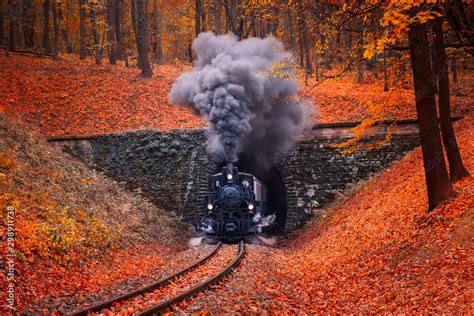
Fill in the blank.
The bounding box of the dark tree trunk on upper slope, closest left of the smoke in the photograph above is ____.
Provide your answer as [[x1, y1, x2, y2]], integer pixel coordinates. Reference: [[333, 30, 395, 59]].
[[137, 0, 153, 78]]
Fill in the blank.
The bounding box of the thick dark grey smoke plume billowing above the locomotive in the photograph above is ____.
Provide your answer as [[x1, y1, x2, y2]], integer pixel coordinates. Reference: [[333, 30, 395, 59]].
[[169, 32, 313, 165]]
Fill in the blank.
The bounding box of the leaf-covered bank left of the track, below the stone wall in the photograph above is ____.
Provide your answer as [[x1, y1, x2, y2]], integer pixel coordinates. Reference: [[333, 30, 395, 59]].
[[0, 114, 187, 311]]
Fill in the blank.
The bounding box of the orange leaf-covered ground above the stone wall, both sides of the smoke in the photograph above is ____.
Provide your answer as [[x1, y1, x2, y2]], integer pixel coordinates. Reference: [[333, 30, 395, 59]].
[[0, 54, 474, 136]]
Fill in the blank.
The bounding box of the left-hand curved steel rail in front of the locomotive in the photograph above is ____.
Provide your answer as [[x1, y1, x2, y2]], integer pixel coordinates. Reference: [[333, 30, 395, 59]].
[[70, 242, 222, 316]]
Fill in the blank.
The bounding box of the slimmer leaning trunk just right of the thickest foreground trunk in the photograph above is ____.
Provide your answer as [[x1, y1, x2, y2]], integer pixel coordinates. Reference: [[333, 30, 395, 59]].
[[433, 18, 469, 181]]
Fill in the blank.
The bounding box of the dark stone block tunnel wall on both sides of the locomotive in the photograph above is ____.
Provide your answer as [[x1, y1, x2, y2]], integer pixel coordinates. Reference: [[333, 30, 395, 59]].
[[50, 121, 419, 231]]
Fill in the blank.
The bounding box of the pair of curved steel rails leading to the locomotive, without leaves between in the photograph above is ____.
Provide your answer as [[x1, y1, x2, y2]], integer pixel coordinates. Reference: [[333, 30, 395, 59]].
[[71, 241, 245, 316]]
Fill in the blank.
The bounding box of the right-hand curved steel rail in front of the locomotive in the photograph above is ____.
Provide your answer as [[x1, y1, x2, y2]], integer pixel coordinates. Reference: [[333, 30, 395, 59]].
[[136, 241, 245, 316]]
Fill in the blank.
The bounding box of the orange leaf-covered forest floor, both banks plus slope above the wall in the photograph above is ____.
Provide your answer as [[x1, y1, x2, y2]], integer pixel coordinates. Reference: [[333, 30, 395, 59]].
[[0, 54, 474, 314]]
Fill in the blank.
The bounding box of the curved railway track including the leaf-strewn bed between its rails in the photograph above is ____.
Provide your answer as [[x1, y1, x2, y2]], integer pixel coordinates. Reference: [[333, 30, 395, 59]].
[[72, 241, 245, 316]]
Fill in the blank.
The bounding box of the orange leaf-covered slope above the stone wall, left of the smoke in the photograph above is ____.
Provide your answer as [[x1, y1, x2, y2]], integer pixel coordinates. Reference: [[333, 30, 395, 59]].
[[0, 54, 204, 136]]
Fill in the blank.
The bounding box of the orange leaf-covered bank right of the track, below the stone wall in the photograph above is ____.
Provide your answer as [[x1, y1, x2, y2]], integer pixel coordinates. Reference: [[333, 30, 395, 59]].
[[177, 117, 474, 314]]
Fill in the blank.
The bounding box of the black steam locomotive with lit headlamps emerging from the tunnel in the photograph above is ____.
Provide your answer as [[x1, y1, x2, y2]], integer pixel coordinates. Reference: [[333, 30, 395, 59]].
[[199, 163, 267, 242]]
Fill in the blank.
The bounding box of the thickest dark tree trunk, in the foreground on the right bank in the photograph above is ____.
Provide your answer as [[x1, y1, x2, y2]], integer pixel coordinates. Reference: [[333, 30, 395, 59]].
[[408, 23, 454, 210]]
